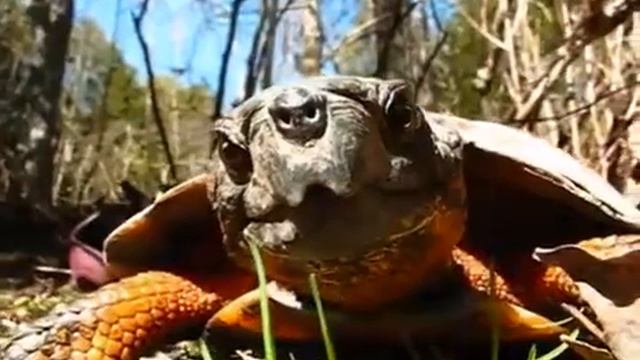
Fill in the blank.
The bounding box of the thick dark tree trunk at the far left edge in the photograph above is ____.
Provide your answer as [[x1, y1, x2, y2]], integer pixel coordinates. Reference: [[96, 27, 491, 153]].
[[0, 0, 73, 209]]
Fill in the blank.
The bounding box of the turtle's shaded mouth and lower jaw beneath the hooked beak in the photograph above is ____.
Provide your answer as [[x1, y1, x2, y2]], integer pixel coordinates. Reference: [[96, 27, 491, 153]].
[[241, 187, 433, 261]]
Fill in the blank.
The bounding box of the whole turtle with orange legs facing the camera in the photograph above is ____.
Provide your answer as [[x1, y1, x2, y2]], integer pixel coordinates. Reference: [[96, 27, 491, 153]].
[[3, 75, 640, 360]]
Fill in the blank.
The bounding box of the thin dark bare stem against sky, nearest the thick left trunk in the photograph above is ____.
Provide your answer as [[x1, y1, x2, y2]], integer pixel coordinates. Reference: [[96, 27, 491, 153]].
[[131, 0, 178, 182]]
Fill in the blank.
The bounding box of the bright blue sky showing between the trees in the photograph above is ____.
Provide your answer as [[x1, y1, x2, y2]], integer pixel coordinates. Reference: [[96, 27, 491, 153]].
[[75, 0, 452, 110]]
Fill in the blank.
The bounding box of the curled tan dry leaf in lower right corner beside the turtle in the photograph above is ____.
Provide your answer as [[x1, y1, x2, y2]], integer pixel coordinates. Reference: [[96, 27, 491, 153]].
[[534, 235, 640, 360]]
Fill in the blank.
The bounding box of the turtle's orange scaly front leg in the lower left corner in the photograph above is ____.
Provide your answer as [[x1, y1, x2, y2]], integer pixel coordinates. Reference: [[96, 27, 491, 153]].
[[2, 271, 222, 360]]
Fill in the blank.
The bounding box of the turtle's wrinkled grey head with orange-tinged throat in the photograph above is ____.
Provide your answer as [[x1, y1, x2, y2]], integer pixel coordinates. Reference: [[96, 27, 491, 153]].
[[210, 79, 465, 310]]
